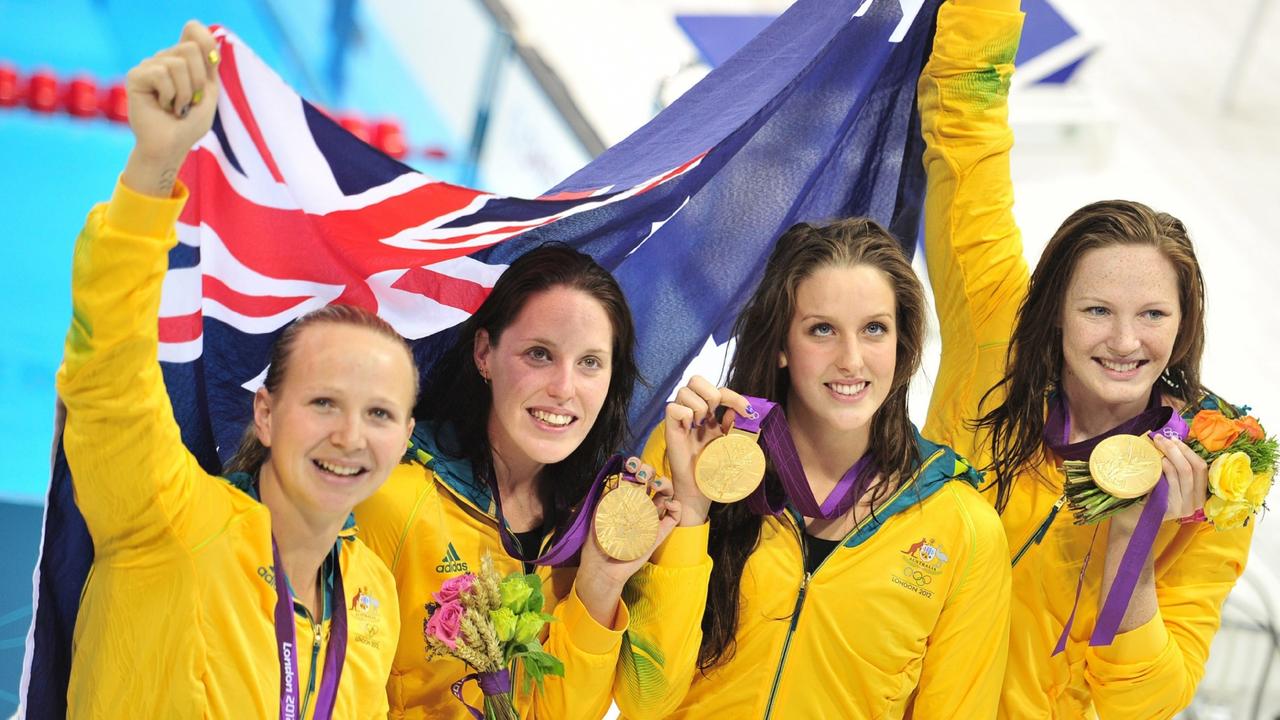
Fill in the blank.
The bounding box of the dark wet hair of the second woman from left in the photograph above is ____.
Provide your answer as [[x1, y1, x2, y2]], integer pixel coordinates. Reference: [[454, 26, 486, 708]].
[[413, 243, 640, 530]]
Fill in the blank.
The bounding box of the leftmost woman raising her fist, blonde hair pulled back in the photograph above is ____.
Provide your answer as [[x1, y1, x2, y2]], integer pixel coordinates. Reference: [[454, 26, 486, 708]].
[[60, 22, 417, 719]]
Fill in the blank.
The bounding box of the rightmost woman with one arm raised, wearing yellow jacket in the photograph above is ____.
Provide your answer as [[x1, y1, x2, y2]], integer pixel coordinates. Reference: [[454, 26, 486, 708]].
[[920, 0, 1252, 719]]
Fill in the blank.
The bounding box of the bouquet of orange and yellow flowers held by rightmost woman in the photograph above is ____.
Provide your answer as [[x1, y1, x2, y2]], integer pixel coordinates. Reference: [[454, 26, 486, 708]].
[[1062, 397, 1277, 530]]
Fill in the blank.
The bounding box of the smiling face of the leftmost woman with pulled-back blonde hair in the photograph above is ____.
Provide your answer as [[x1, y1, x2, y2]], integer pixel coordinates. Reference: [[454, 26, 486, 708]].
[[253, 323, 415, 520]]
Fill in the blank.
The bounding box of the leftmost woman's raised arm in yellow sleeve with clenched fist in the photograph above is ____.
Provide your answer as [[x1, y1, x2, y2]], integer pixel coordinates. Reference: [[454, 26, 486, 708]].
[[58, 23, 218, 548]]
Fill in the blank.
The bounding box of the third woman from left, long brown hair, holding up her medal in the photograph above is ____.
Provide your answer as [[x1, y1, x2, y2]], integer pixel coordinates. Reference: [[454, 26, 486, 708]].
[[616, 211, 1009, 717]]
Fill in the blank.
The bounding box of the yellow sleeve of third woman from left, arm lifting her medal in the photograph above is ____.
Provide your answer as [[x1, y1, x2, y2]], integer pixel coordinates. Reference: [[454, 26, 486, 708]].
[[613, 424, 712, 720]]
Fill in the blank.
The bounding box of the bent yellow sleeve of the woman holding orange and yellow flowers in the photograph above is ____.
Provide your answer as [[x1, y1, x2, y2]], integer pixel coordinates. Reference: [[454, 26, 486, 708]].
[[1084, 523, 1254, 719]]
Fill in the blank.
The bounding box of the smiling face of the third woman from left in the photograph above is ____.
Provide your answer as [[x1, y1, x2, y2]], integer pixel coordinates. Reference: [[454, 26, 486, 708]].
[[780, 265, 899, 443]]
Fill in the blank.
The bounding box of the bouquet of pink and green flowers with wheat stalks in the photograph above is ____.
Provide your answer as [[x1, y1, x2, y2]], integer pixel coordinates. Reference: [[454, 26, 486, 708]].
[[422, 552, 564, 720]]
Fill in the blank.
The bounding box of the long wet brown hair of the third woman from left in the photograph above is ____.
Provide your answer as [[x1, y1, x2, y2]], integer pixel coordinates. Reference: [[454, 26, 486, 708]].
[[698, 218, 925, 671]]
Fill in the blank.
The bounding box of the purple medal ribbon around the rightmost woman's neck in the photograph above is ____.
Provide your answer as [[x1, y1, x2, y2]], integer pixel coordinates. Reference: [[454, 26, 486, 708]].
[[1044, 388, 1189, 655]]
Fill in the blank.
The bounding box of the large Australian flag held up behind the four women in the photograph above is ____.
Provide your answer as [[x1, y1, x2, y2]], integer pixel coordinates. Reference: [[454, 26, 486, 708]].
[[19, 0, 938, 717]]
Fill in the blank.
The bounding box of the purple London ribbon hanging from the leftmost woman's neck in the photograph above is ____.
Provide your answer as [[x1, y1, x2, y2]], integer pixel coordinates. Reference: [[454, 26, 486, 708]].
[[271, 537, 347, 720]]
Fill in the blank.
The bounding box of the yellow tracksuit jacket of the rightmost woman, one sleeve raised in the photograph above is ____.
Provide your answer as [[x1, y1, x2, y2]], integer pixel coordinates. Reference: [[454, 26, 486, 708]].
[[919, 0, 1252, 720]]
